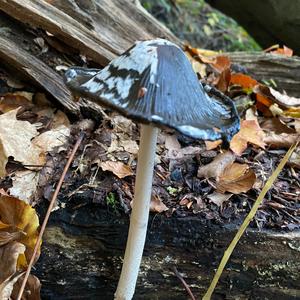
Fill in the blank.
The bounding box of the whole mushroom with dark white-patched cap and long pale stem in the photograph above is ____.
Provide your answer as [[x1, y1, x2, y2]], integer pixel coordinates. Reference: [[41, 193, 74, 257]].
[[65, 39, 239, 300]]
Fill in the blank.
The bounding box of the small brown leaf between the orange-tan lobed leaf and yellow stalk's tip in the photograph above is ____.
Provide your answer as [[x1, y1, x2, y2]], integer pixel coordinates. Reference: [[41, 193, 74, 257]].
[[264, 132, 300, 149]]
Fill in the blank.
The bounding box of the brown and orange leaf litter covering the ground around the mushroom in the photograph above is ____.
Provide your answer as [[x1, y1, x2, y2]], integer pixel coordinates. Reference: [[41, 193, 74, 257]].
[[0, 38, 300, 294]]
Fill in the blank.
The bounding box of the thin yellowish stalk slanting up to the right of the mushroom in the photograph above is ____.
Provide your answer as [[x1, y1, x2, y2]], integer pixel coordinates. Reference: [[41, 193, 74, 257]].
[[202, 143, 298, 300]]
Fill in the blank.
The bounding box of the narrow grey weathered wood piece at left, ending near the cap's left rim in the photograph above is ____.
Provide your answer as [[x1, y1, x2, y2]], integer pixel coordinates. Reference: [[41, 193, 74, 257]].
[[0, 34, 79, 115]]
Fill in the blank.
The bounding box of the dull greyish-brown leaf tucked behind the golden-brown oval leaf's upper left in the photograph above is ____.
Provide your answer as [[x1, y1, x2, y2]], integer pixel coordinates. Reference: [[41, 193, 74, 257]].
[[197, 151, 235, 178]]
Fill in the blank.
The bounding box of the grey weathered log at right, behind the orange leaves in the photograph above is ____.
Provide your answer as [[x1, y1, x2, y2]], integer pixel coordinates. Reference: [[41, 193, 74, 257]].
[[228, 52, 300, 97]]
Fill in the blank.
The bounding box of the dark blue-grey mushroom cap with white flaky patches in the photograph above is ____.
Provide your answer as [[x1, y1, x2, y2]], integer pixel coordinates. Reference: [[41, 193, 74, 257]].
[[65, 39, 239, 140]]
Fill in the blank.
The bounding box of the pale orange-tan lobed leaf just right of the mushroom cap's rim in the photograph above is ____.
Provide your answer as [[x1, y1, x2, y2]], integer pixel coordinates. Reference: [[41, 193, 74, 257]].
[[230, 120, 265, 155]]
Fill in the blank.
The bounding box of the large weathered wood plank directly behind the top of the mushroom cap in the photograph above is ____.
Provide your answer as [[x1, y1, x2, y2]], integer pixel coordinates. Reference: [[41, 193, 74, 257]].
[[0, 0, 177, 66]]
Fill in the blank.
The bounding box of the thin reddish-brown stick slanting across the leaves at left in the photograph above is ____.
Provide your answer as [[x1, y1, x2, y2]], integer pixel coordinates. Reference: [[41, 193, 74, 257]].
[[17, 132, 84, 300]]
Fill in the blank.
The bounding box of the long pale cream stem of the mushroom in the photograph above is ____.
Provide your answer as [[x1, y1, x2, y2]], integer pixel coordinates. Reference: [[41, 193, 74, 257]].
[[115, 125, 158, 300]]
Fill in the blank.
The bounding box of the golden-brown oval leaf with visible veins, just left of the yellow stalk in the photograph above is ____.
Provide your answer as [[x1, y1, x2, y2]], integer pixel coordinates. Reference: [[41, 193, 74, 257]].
[[217, 163, 256, 194]]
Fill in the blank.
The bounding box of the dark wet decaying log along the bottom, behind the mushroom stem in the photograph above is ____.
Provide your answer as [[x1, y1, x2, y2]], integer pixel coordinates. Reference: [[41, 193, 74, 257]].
[[34, 205, 300, 300]]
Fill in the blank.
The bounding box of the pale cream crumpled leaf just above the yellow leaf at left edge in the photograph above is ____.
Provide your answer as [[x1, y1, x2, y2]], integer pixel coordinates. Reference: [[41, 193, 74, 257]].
[[9, 170, 39, 204]]
